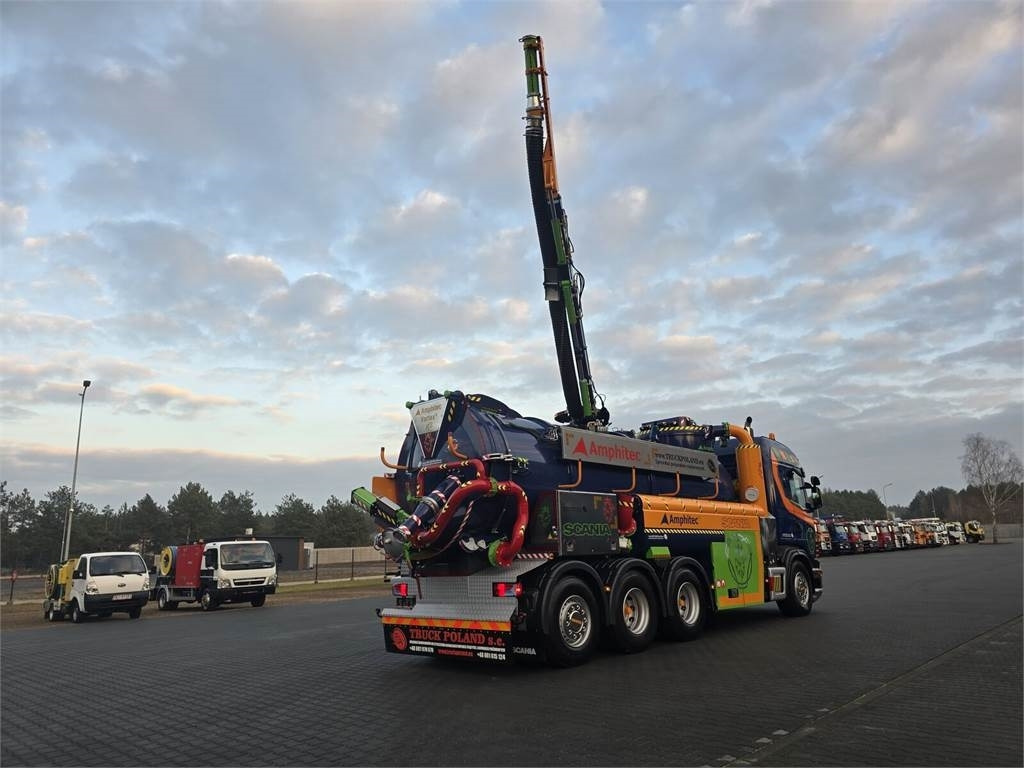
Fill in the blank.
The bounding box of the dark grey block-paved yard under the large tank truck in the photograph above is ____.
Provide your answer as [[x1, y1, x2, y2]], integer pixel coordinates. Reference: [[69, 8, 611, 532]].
[[0, 542, 1024, 766]]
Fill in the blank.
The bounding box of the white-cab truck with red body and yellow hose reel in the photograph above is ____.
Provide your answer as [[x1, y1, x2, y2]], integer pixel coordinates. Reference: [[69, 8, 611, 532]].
[[153, 539, 281, 610]]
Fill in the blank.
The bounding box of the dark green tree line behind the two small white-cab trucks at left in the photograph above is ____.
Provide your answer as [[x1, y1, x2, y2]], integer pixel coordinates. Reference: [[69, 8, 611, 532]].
[[0, 480, 375, 571]]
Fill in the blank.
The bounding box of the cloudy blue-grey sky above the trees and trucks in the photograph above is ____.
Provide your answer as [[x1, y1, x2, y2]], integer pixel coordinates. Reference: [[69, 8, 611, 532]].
[[0, 0, 1024, 518]]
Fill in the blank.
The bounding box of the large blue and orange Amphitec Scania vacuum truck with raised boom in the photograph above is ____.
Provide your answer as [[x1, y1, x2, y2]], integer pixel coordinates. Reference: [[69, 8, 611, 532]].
[[352, 36, 822, 667]]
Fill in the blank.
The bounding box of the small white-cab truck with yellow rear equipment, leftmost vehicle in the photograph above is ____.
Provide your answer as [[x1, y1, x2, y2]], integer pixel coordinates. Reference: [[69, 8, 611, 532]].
[[43, 552, 150, 624]]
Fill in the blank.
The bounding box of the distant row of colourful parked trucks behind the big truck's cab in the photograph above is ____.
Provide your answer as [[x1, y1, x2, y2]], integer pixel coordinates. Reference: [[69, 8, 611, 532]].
[[815, 516, 985, 556]]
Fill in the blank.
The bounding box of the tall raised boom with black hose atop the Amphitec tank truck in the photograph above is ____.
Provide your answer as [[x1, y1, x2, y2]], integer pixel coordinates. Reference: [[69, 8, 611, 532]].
[[520, 35, 608, 429]]
